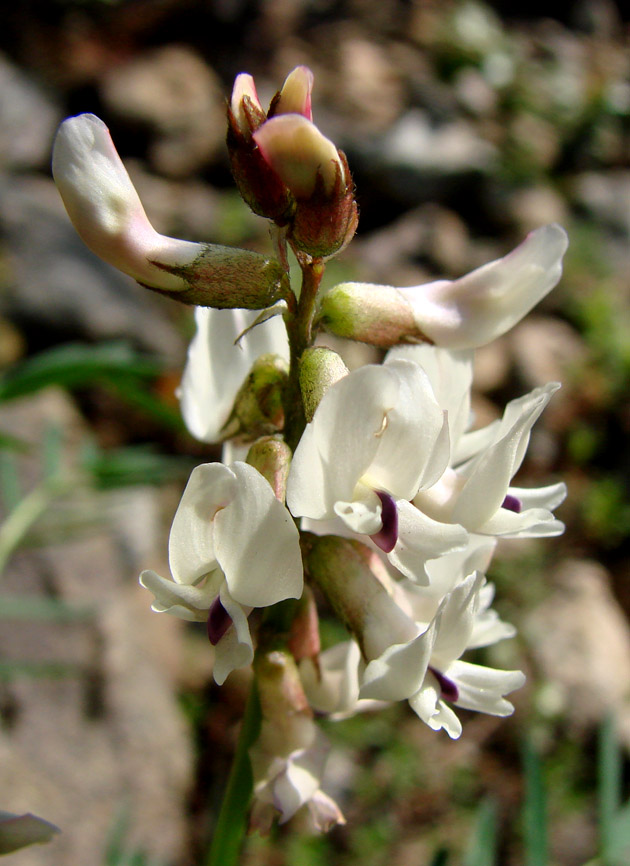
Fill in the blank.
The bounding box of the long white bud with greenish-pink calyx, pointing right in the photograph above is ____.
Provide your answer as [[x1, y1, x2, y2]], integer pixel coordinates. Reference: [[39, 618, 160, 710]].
[[321, 224, 567, 349]]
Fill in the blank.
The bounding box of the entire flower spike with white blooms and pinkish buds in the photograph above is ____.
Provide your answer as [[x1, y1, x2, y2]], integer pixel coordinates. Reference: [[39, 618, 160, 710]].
[[53, 67, 567, 829]]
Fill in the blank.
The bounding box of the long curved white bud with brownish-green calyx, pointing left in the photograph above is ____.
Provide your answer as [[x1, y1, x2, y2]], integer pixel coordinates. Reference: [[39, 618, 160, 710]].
[[52, 114, 290, 309]]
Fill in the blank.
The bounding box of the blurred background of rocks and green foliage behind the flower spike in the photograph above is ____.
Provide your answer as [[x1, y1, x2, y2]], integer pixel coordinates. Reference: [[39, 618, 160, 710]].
[[0, 0, 630, 866]]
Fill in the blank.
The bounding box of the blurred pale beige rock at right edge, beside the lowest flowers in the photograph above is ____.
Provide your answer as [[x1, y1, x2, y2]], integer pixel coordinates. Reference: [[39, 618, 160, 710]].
[[524, 559, 630, 749]]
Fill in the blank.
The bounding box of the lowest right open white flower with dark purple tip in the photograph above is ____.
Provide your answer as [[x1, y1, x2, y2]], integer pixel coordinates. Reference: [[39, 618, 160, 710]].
[[360, 572, 525, 738]]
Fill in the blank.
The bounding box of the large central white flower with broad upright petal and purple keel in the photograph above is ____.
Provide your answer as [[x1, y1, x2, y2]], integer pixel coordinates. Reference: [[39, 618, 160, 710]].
[[287, 360, 467, 574]]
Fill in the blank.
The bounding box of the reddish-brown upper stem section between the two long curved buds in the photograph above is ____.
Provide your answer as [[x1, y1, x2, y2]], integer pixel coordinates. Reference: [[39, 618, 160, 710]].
[[283, 254, 324, 451]]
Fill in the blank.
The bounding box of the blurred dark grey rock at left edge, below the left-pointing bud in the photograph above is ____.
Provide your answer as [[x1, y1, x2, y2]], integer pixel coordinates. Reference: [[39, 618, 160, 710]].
[[0, 177, 184, 364]]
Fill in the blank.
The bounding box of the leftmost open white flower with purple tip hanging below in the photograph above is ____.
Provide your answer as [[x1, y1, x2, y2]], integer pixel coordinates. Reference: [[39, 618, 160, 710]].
[[140, 462, 303, 684]]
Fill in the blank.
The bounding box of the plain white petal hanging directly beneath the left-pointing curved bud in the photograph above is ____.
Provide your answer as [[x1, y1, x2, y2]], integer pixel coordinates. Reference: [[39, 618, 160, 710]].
[[179, 307, 289, 442]]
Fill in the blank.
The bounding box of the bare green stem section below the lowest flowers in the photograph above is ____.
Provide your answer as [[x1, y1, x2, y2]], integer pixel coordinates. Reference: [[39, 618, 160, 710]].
[[206, 680, 260, 866]]
